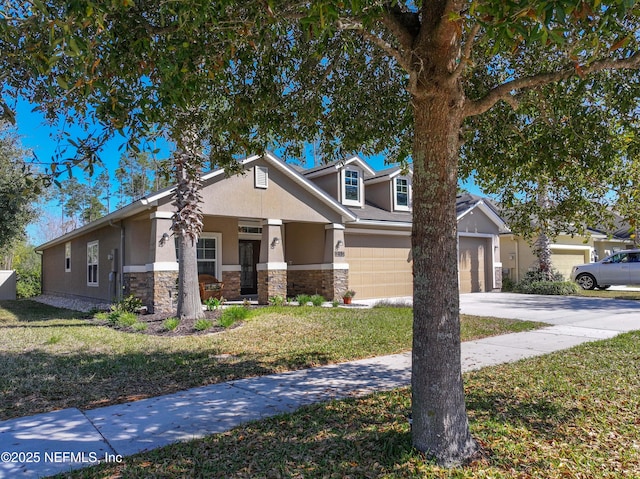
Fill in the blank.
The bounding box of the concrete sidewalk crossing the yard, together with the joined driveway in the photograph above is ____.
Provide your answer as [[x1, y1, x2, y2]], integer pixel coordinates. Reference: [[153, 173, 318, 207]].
[[0, 294, 640, 479]]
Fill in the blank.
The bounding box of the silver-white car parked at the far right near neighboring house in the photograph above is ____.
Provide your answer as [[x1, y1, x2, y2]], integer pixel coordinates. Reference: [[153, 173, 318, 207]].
[[571, 249, 640, 289]]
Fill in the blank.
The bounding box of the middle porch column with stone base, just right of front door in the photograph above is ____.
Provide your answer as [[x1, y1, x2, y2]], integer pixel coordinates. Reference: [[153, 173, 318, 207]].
[[256, 219, 287, 304]]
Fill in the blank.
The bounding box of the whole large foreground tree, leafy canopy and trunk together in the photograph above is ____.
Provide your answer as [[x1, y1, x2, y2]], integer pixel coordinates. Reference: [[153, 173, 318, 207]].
[[0, 0, 640, 465]]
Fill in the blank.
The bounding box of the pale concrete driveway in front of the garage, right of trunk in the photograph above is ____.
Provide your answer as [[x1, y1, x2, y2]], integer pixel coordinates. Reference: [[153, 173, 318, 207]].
[[460, 293, 640, 331]]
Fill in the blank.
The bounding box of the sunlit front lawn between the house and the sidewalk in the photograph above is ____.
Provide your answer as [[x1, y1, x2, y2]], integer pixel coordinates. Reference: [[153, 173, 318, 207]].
[[0, 300, 539, 420]]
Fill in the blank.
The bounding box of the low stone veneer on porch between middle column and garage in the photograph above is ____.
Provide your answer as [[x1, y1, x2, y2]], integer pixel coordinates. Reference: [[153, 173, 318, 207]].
[[287, 269, 349, 301]]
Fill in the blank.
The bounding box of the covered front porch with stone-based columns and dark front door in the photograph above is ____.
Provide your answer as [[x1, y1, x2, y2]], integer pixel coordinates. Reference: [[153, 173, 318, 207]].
[[123, 216, 349, 312]]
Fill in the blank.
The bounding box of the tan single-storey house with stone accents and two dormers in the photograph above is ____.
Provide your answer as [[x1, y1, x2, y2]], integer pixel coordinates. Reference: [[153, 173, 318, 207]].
[[38, 153, 507, 311]]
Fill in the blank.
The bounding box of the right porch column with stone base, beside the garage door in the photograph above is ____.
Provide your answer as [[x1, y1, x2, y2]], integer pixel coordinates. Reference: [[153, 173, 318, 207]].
[[322, 223, 349, 299]]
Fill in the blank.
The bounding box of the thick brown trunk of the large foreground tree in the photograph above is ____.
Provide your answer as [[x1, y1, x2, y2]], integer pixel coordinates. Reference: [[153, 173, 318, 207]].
[[412, 22, 478, 466]]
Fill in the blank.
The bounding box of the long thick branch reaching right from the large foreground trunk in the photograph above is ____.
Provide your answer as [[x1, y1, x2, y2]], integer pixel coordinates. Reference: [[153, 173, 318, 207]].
[[463, 52, 640, 118]]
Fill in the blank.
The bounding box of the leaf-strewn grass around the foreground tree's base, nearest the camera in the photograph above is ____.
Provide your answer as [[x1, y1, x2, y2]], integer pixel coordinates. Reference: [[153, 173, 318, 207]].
[[53, 332, 640, 479]]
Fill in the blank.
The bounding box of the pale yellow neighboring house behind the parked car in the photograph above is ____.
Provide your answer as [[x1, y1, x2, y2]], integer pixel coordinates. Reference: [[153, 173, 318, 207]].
[[500, 219, 633, 281]]
